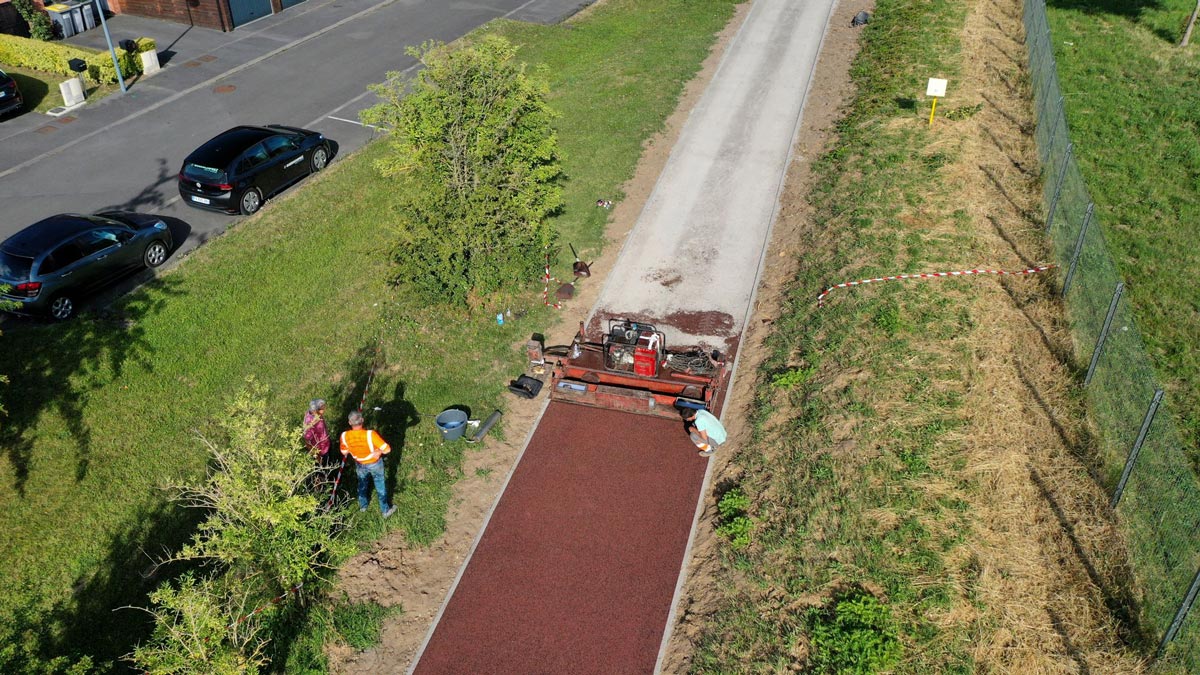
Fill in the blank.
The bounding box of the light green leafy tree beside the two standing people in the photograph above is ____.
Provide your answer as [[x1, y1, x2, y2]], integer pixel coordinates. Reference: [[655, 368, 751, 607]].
[[135, 380, 353, 675]]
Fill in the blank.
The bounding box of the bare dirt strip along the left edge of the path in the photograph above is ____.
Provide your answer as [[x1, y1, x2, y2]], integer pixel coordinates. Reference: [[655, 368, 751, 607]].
[[330, 2, 748, 674]]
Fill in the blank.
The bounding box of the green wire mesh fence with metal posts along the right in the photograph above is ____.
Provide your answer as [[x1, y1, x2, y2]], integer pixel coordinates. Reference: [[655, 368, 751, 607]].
[[1025, 0, 1200, 673]]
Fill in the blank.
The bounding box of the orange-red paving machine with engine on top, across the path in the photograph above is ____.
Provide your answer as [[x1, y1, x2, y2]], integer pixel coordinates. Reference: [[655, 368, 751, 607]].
[[546, 318, 725, 417]]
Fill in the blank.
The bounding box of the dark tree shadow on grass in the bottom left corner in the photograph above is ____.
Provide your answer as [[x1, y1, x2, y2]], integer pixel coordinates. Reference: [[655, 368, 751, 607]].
[[0, 501, 204, 673]]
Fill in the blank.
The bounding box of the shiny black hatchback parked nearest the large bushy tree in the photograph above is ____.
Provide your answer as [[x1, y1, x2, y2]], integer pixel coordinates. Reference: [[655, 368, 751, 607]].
[[179, 124, 331, 215]]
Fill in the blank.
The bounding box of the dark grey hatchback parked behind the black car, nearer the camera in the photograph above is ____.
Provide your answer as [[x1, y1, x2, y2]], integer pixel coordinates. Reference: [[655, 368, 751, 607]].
[[0, 211, 173, 319]]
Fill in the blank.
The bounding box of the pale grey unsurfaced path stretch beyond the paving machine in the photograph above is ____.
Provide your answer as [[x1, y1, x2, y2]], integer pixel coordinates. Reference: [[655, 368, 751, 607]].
[[592, 0, 834, 351]]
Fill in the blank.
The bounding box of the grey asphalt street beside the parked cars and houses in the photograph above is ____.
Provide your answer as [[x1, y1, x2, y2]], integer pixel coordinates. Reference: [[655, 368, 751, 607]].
[[0, 0, 592, 259]]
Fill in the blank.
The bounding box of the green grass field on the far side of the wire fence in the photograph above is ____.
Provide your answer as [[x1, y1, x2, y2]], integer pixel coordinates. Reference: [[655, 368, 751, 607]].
[[1046, 0, 1200, 458]]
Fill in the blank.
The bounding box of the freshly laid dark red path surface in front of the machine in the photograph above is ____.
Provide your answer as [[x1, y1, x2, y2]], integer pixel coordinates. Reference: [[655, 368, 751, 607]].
[[416, 401, 707, 675]]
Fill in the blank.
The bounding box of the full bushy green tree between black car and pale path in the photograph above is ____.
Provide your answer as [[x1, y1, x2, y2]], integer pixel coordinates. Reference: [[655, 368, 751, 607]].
[[362, 36, 563, 305]]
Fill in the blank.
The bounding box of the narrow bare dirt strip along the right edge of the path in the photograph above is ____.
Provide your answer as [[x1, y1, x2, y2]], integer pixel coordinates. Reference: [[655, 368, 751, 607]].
[[662, 1, 875, 673]]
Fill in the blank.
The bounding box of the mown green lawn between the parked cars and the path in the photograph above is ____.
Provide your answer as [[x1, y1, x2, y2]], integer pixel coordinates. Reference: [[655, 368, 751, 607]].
[[0, 0, 733, 659]]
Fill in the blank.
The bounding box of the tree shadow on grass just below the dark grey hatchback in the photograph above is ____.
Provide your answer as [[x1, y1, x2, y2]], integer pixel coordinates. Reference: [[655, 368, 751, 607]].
[[0, 279, 180, 497]]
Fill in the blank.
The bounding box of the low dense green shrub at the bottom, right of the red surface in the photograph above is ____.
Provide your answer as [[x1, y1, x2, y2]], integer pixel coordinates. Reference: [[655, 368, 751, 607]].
[[808, 589, 901, 675]]
